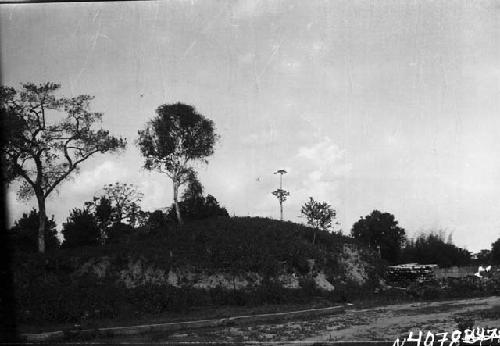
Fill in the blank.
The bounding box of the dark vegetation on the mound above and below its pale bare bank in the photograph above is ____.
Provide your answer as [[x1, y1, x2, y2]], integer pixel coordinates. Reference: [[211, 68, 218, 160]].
[[15, 217, 382, 324]]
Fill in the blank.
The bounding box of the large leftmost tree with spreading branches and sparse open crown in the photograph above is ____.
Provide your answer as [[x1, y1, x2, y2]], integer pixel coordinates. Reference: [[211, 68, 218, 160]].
[[0, 83, 126, 253]]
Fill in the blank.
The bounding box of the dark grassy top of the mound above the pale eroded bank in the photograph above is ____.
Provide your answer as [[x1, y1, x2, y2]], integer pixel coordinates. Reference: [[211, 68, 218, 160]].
[[38, 217, 376, 274]]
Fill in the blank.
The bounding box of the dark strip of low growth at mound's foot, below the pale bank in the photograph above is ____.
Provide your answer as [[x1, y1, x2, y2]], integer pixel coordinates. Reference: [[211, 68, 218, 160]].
[[16, 278, 330, 325]]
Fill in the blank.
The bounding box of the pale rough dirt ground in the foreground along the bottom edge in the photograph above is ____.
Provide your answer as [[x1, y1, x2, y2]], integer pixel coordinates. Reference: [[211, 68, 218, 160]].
[[95, 297, 500, 344]]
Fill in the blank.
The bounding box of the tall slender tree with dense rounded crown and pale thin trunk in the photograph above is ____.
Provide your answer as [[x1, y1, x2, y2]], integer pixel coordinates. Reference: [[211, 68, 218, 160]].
[[137, 103, 219, 224]]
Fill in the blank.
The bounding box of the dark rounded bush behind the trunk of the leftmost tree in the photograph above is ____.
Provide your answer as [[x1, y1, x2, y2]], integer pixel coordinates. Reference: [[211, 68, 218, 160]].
[[10, 209, 59, 252]]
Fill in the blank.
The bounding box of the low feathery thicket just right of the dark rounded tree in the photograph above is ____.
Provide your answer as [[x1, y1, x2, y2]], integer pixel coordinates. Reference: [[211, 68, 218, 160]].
[[401, 233, 471, 267]]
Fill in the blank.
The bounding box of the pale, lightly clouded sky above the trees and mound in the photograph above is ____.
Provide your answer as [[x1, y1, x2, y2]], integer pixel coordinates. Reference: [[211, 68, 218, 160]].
[[0, 0, 500, 251]]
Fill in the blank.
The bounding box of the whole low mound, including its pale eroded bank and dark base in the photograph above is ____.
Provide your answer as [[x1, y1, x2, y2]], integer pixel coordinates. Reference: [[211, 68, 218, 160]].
[[15, 217, 378, 322]]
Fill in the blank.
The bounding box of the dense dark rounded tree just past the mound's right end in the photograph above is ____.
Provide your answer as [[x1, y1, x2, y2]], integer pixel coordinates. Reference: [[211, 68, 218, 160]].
[[351, 210, 406, 263]]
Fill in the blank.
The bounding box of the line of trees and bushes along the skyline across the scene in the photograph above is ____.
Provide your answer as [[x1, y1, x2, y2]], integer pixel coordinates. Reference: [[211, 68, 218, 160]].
[[0, 82, 500, 266]]
